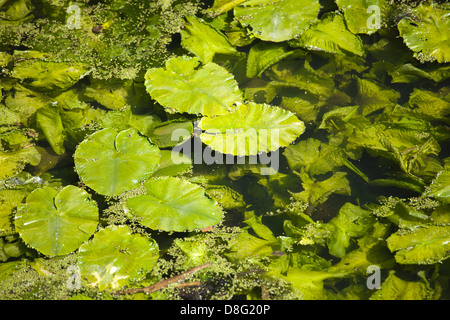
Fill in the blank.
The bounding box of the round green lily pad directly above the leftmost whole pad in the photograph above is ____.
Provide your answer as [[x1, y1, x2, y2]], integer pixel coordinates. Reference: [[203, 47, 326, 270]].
[[74, 128, 160, 196]]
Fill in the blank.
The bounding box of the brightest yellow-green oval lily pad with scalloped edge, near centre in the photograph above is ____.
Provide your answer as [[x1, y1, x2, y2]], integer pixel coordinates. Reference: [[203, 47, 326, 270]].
[[199, 102, 305, 156]]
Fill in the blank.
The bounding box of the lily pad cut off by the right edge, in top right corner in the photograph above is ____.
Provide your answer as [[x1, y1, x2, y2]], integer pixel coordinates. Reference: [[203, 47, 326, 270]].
[[397, 3, 450, 63]]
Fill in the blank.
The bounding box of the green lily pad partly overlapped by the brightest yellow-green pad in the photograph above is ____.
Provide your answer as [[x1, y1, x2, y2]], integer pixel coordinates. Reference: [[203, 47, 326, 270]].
[[145, 57, 242, 115]]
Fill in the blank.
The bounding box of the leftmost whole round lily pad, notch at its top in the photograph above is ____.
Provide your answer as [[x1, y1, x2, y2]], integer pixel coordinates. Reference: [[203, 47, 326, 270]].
[[15, 186, 98, 256]]
